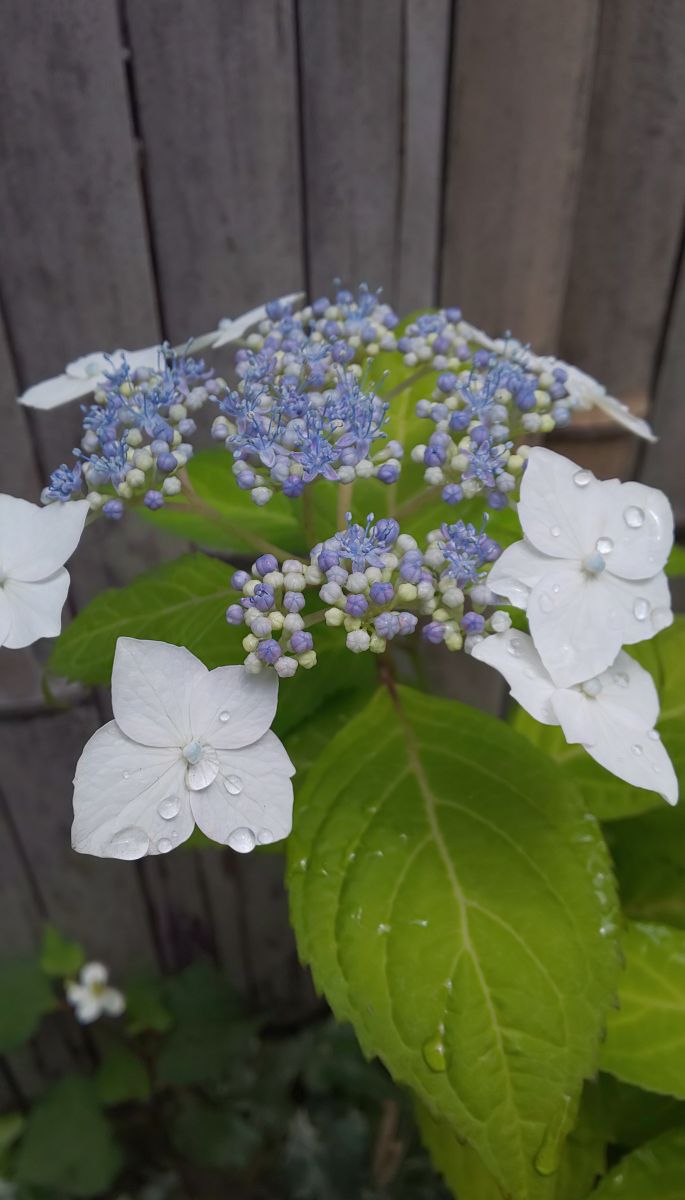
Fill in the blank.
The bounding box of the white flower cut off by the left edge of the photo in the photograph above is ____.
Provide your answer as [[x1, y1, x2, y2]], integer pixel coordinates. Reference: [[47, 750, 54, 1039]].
[[0, 496, 90, 650]]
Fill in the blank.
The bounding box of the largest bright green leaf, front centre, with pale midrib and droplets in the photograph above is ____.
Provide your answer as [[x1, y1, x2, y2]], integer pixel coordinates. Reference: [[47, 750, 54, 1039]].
[[288, 689, 618, 1200]]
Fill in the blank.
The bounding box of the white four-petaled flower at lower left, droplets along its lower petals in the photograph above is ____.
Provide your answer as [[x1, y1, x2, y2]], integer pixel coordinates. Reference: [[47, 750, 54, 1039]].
[[72, 637, 295, 859]]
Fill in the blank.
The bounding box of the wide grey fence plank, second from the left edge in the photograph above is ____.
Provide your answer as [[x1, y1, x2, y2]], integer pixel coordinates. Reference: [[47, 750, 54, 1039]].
[[125, 0, 304, 340]]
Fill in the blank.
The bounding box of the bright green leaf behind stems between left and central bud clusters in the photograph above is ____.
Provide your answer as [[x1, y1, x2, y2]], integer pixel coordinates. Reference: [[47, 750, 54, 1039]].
[[137, 448, 306, 554]]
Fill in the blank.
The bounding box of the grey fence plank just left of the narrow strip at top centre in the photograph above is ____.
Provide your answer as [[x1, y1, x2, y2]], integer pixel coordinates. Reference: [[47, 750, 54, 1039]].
[[299, 0, 403, 300]]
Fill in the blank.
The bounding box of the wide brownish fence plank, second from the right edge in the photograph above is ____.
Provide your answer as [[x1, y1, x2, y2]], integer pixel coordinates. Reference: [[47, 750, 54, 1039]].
[[441, 0, 597, 350]]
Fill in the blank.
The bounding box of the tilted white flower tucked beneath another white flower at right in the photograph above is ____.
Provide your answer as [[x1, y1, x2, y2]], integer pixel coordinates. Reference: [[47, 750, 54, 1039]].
[[473, 629, 678, 804]]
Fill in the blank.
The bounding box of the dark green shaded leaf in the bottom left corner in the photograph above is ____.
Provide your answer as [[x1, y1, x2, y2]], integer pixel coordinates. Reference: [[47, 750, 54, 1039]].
[[17, 1075, 121, 1196]]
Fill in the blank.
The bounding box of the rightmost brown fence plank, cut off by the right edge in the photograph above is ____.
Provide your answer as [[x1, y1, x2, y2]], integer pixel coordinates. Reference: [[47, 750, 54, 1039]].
[[561, 0, 685, 402]]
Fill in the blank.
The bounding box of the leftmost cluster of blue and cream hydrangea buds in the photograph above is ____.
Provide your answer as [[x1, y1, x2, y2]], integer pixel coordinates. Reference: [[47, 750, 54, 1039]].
[[42, 346, 228, 520]]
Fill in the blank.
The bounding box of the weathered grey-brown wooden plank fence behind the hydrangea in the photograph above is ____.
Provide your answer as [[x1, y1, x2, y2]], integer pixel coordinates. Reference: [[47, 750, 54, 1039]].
[[0, 0, 685, 1105]]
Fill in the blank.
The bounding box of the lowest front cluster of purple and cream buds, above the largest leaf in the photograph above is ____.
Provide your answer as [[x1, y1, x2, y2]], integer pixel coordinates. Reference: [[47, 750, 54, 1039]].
[[227, 512, 511, 678]]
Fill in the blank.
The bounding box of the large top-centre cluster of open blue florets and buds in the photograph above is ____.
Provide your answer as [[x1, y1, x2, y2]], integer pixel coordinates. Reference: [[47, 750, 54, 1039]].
[[212, 287, 403, 505]]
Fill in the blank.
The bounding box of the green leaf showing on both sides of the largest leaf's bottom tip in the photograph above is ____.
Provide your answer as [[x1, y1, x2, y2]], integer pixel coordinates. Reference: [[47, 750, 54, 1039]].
[[416, 1084, 607, 1200]]
